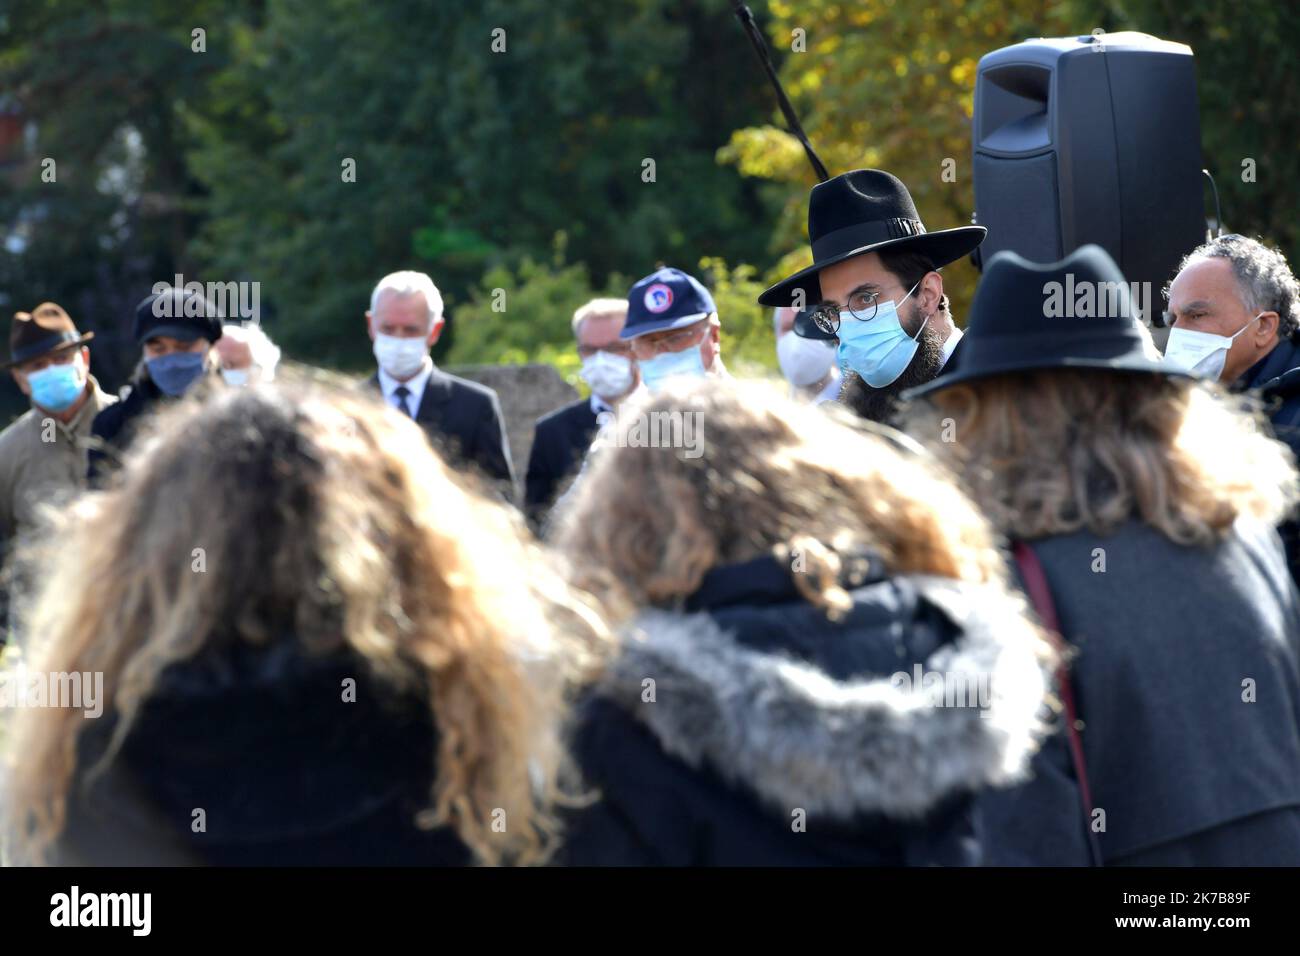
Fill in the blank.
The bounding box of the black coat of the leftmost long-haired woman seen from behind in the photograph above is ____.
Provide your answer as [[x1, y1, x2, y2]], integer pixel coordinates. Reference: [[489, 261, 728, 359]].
[[57, 641, 469, 866]]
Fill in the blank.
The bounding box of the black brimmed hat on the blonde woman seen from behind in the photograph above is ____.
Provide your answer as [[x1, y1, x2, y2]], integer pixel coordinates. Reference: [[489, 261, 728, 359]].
[[902, 246, 1186, 399]]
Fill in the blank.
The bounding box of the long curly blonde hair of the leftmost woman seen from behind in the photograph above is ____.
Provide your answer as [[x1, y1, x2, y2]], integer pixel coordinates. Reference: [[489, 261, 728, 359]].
[[4, 375, 606, 864]]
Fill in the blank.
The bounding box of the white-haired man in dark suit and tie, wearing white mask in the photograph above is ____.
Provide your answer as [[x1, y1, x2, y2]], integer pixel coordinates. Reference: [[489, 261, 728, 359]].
[[365, 272, 515, 499]]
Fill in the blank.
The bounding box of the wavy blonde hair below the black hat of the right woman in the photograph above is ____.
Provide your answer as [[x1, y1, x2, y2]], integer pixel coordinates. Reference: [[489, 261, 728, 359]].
[[904, 369, 1300, 545]]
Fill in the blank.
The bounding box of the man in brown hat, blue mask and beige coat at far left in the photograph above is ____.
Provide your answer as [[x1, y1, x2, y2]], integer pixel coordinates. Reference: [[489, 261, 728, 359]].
[[0, 302, 117, 644]]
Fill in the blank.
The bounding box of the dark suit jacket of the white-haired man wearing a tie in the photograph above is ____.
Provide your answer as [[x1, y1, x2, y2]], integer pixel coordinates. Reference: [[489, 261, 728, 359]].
[[367, 368, 515, 498]]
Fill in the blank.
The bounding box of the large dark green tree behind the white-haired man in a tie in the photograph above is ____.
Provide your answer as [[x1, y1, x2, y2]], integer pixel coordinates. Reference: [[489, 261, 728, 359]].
[[191, 0, 768, 364]]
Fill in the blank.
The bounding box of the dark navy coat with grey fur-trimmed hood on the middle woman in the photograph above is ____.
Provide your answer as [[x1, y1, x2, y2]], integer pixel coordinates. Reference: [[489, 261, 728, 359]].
[[562, 558, 1045, 866]]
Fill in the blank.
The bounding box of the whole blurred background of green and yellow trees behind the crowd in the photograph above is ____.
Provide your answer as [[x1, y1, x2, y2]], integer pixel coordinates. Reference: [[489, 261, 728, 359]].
[[0, 0, 1300, 421]]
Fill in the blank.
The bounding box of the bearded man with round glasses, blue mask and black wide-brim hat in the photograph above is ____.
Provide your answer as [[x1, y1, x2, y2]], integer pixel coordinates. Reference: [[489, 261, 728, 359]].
[[758, 169, 987, 421]]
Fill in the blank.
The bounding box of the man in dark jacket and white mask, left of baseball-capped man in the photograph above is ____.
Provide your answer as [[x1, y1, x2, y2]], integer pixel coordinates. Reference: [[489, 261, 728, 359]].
[[524, 299, 641, 525]]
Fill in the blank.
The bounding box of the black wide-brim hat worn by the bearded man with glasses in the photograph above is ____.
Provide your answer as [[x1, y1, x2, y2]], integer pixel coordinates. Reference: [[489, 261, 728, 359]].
[[758, 169, 988, 308]]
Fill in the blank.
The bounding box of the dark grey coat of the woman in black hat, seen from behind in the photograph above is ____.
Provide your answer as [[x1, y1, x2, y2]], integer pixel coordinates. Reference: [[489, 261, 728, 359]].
[[1019, 519, 1300, 866]]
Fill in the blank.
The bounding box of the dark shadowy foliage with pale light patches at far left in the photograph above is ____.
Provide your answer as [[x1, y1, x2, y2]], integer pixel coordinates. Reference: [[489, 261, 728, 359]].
[[0, 0, 260, 398]]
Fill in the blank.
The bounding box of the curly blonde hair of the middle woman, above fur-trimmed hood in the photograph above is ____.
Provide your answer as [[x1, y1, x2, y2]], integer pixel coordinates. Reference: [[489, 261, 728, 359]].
[[555, 380, 1004, 613]]
